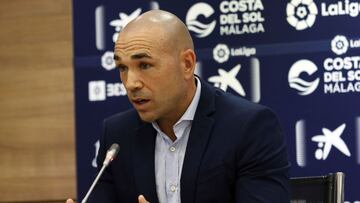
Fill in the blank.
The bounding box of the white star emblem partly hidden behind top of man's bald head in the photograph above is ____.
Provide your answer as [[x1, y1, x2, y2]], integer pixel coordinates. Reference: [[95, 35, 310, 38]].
[[110, 8, 141, 42]]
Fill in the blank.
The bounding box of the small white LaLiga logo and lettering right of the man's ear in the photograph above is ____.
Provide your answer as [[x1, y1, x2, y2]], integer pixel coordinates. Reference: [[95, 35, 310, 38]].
[[213, 44, 256, 63]]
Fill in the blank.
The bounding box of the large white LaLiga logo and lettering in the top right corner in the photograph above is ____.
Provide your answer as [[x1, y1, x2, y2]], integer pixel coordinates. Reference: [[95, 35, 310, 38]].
[[286, 0, 360, 31]]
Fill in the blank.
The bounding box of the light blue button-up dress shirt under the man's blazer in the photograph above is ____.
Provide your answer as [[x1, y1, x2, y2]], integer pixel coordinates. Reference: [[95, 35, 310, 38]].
[[152, 78, 201, 203]]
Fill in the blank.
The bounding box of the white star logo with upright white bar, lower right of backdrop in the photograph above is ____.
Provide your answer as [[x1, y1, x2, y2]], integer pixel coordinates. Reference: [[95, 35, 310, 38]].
[[295, 117, 360, 167]]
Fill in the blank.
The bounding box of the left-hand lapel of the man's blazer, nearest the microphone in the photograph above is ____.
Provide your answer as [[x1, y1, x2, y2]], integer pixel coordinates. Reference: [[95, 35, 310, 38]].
[[132, 123, 158, 203]]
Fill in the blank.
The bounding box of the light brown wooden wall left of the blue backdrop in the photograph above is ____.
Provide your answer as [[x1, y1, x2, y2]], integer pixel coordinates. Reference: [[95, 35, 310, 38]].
[[0, 0, 75, 202]]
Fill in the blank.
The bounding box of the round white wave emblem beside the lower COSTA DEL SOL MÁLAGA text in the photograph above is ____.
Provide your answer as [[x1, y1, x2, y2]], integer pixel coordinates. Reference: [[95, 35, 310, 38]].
[[288, 59, 320, 96]]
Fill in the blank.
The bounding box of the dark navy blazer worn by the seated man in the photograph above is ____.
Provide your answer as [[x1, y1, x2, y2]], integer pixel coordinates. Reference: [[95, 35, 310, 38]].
[[91, 81, 290, 203]]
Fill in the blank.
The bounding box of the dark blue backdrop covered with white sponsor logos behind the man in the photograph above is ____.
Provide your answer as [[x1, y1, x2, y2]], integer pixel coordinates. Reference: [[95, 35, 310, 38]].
[[73, 0, 360, 202]]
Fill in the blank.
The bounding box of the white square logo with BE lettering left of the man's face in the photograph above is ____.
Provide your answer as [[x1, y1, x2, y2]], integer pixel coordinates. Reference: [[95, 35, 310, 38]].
[[88, 80, 126, 101]]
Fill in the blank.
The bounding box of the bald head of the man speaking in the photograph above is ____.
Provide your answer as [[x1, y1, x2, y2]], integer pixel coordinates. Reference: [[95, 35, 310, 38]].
[[114, 10, 196, 126]]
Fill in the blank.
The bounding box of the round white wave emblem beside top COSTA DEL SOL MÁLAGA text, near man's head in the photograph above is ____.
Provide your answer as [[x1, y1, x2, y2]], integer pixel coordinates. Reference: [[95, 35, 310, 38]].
[[186, 2, 216, 38]]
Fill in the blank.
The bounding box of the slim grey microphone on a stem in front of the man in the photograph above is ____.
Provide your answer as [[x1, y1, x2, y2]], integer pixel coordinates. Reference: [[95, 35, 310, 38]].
[[81, 143, 120, 203]]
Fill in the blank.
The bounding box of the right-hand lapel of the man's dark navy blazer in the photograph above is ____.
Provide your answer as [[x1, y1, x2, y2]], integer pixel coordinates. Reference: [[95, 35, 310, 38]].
[[181, 81, 215, 203]]
